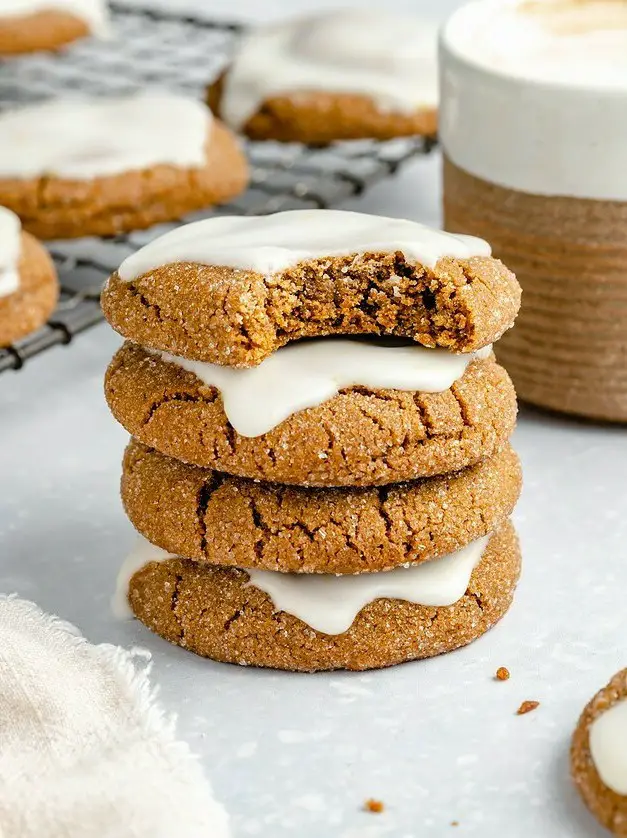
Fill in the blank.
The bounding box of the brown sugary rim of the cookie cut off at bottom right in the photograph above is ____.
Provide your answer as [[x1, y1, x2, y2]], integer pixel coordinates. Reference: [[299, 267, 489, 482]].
[[570, 669, 627, 836]]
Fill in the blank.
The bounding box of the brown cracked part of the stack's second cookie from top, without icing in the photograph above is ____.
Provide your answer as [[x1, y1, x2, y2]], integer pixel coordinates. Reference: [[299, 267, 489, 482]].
[[105, 343, 517, 486]]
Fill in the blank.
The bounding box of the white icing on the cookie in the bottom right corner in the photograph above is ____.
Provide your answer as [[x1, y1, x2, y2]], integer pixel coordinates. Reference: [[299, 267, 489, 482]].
[[589, 699, 627, 796]]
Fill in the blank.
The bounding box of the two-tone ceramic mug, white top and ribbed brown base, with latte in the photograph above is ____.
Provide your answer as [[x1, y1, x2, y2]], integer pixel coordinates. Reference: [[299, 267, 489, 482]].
[[440, 0, 627, 421]]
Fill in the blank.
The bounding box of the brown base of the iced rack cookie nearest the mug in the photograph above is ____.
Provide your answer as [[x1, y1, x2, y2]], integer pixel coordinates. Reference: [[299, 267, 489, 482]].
[[207, 70, 438, 145]]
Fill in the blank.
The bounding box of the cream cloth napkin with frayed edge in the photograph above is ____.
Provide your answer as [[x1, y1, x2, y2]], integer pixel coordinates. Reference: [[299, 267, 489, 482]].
[[0, 596, 229, 838]]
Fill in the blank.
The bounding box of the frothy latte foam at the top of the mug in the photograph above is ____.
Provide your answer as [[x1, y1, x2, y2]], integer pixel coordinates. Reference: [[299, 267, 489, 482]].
[[447, 0, 627, 89]]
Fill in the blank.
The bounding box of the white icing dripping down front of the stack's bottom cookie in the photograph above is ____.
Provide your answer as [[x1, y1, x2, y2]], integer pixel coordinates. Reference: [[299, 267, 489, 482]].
[[246, 536, 490, 634]]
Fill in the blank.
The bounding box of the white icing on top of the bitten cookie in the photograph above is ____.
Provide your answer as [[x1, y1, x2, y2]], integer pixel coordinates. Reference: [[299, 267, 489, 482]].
[[118, 210, 491, 281]]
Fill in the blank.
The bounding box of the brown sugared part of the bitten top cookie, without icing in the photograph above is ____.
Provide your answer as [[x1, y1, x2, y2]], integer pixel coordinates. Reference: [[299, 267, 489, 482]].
[[102, 251, 521, 367]]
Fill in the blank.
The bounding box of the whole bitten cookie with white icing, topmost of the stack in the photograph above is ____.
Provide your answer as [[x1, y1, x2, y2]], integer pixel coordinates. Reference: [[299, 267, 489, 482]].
[[102, 210, 520, 367]]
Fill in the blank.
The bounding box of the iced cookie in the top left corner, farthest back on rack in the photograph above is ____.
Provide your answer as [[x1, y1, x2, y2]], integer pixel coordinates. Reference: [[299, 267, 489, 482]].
[[0, 0, 108, 57]]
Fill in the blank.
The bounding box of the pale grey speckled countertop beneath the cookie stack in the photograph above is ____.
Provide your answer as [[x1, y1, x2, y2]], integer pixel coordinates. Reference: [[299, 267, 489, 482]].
[[0, 3, 627, 838]]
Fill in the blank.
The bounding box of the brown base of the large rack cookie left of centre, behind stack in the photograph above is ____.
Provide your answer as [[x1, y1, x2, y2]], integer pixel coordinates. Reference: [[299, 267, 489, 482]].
[[0, 120, 248, 239]]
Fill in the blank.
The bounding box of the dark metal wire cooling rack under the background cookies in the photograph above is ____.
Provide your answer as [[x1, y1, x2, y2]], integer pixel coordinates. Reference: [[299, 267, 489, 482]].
[[0, 3, 434, 372]]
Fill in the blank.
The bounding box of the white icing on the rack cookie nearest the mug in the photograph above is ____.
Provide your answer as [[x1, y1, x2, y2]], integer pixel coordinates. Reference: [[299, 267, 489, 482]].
[[220, 9, 438, 129]]
